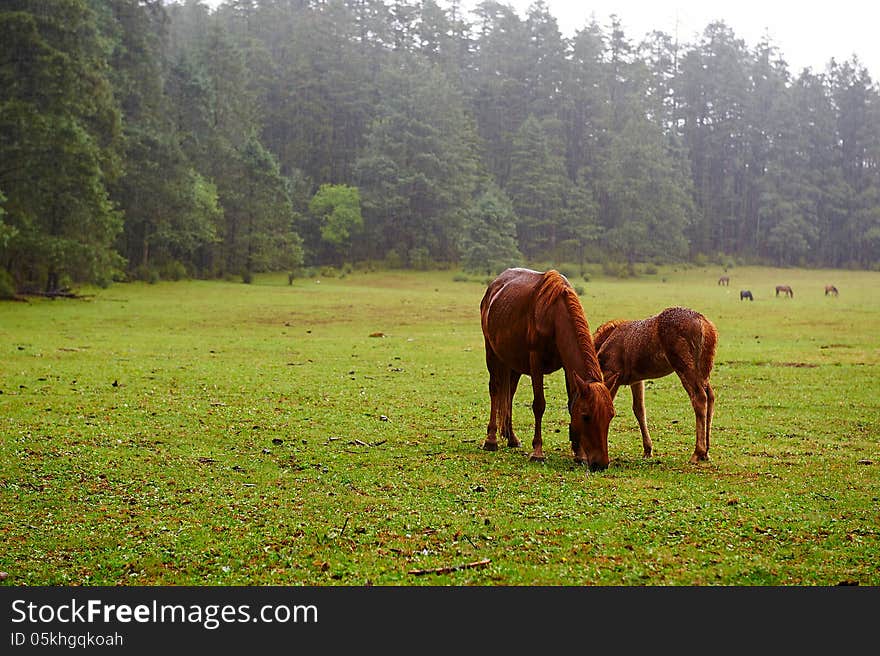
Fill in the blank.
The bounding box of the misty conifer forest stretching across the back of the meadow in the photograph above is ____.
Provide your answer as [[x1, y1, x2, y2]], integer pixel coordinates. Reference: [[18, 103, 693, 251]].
[[0, 0, 880, 291]]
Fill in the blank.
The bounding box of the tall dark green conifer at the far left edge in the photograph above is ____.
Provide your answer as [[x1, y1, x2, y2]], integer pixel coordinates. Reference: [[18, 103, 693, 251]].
[[0, 0, 122, 292]]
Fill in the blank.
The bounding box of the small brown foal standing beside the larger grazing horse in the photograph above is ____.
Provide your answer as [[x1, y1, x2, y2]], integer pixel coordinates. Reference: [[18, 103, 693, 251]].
[[593, 307, 718, 464]]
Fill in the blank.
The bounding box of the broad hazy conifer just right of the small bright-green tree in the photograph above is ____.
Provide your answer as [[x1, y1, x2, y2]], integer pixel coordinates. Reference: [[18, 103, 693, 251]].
[[355, 56, 482, 265]]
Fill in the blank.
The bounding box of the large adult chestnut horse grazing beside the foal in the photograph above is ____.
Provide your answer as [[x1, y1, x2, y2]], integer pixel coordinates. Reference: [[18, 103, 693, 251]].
[[480, 268, 614, 471]]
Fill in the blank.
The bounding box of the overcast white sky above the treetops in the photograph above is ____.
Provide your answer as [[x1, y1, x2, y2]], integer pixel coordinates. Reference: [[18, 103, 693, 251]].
[[203, 0, 880, 81]]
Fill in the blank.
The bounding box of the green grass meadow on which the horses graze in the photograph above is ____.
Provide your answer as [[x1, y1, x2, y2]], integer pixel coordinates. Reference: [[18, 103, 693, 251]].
[[0, 267, 880, 586]]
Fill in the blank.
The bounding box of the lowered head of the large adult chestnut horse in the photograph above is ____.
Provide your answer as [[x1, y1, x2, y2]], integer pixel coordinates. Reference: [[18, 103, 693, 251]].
[[568, 374, 614, 471]]
